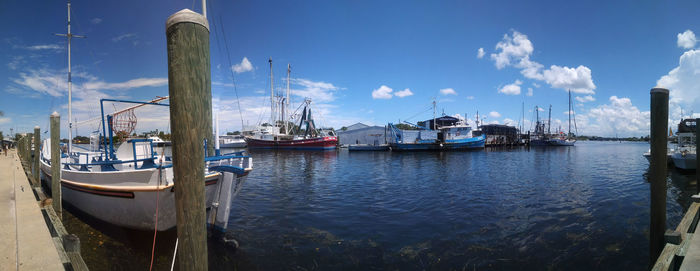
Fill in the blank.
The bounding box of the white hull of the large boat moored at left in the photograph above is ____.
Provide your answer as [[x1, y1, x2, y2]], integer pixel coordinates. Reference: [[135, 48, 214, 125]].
[[41, 161, 246, 231]]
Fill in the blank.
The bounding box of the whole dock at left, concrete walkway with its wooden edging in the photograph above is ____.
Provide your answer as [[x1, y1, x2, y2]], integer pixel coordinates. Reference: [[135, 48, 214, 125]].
[[0, 149, 87, 270]]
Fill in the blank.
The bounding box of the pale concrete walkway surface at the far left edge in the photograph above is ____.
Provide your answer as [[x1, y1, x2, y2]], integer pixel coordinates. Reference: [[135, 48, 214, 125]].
[[0, 150, 64, 270]]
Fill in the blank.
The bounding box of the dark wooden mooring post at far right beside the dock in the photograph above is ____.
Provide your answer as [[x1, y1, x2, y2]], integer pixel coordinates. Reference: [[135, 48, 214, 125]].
[[649, 88, 668, 264]]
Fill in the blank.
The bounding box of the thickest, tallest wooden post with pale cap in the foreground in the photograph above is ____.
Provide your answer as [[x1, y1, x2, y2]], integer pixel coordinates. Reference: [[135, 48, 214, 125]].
[[166, 9, 213, 270]]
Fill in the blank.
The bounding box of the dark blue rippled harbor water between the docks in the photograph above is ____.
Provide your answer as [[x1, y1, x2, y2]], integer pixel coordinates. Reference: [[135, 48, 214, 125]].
[[67, 142, 695, 270]]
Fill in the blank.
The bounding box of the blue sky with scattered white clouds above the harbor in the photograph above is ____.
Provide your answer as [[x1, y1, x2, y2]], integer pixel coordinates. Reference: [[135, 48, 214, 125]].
[[0, 0, 700, 137]]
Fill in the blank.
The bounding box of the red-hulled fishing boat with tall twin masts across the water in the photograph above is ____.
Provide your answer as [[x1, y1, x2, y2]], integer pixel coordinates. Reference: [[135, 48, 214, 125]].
[[245, 59, 338, 150]]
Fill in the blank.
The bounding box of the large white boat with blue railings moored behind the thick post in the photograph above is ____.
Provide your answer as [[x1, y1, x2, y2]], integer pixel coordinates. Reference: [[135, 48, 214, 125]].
[[40, 3, 253, 231]]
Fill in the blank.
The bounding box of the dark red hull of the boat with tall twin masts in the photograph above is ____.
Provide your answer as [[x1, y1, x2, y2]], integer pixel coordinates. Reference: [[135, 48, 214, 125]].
[[245, 136, 338, 150]]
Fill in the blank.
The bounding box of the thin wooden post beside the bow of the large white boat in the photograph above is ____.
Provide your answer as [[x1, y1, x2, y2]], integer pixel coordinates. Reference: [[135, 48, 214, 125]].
[[50, 112, 63, 220]]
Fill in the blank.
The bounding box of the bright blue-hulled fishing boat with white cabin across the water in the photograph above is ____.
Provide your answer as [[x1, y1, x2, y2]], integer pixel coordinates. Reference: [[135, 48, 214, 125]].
[[389, 101, 486, 151]]
